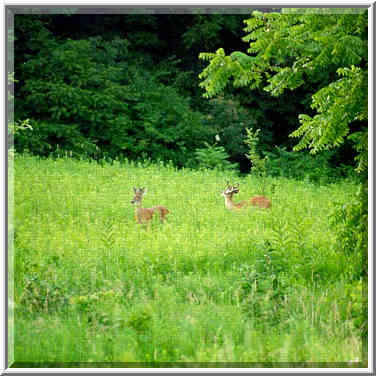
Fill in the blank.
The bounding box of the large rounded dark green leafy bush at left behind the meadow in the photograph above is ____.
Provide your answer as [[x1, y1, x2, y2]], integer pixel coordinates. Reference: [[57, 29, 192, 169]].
[[16, 37, 206, 166]]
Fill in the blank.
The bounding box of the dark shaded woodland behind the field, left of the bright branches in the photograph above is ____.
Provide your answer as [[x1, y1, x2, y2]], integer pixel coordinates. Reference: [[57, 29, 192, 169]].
[[15, 14, 256, 167]]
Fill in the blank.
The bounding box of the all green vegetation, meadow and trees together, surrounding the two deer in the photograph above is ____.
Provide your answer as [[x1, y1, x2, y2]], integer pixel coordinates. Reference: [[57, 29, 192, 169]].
[[8, 7, 368, 367]]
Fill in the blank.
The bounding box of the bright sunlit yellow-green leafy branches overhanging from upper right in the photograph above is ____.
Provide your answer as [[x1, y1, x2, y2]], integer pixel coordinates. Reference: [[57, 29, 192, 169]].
[[200, 11, 368, 171]]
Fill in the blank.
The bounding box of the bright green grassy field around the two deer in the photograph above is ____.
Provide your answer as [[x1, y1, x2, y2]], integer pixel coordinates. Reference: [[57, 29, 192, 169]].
[[11, 156, 362, 366]]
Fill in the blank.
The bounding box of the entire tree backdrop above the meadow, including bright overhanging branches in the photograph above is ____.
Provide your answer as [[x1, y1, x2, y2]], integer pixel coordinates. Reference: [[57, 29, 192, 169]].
[[14, 9, 367, 177]]
